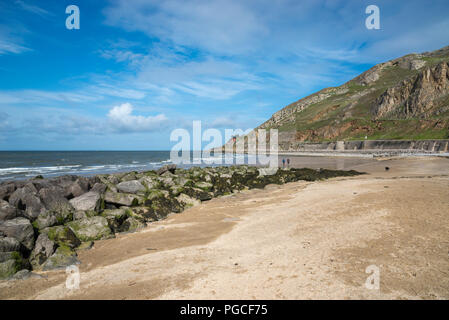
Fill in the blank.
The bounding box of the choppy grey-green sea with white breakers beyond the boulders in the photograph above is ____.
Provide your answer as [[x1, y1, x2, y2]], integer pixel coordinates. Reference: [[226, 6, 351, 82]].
[[0, 151, 260, 181]]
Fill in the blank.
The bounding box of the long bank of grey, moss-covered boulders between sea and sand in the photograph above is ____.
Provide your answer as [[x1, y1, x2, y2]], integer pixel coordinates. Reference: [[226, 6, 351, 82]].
[[0, 165, 360, 279]]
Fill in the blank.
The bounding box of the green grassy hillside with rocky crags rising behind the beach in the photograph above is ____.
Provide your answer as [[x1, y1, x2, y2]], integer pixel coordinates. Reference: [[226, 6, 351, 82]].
[[255, 46, 449, 143]]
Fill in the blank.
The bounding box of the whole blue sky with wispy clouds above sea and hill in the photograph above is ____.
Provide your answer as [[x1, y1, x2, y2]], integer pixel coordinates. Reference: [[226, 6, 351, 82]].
[[0, 0, 449, 150]]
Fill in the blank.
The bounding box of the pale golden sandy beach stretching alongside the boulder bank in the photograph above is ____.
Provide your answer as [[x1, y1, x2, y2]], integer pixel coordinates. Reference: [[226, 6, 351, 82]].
[[0, 157, 449, 299]]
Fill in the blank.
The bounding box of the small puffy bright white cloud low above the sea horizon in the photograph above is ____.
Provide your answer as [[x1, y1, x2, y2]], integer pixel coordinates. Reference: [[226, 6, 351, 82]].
[[108, 103, 167, 132]]
